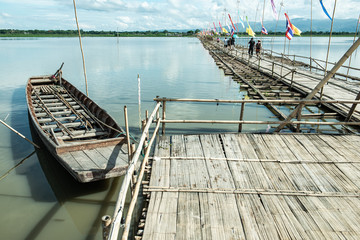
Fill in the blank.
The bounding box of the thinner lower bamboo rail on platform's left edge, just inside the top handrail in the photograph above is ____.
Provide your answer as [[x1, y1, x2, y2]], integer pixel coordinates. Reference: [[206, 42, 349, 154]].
[[121, 119, 160, 240]]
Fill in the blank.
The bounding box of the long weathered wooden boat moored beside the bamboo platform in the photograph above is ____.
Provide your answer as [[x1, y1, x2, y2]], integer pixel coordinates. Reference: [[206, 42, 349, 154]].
[[26, 71, 128, 182]]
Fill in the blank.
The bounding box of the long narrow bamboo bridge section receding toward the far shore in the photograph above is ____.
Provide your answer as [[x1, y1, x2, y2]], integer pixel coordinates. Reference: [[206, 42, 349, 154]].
[[203, 42, 360, 121]]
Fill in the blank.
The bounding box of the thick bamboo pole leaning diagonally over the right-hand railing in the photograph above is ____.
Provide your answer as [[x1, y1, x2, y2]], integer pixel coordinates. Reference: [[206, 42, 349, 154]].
[[275, 38, 360, 132]]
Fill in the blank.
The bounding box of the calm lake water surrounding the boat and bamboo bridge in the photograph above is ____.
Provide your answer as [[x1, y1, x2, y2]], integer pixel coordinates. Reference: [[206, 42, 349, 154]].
[[0, 38, 360, 239]]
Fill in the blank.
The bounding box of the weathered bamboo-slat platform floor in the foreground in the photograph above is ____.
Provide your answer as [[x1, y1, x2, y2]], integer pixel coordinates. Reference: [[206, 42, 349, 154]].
[[142, 133, 360, 240]]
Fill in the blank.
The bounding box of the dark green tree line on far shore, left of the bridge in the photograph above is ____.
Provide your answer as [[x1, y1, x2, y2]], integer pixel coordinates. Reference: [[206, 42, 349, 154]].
[[0, 29, 200, 37]]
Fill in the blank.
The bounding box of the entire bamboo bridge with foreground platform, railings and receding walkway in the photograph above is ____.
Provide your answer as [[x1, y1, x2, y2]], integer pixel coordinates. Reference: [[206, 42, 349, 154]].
[[104, 36, 360, 240]]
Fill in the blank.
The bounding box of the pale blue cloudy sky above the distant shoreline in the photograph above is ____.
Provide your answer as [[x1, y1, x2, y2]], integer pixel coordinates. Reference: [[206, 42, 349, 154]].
[[0, 0, 360, 31]]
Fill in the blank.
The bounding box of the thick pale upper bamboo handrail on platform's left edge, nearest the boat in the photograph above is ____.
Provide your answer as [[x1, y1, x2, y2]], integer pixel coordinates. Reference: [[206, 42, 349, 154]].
[[109, 103, 161, 240]]
